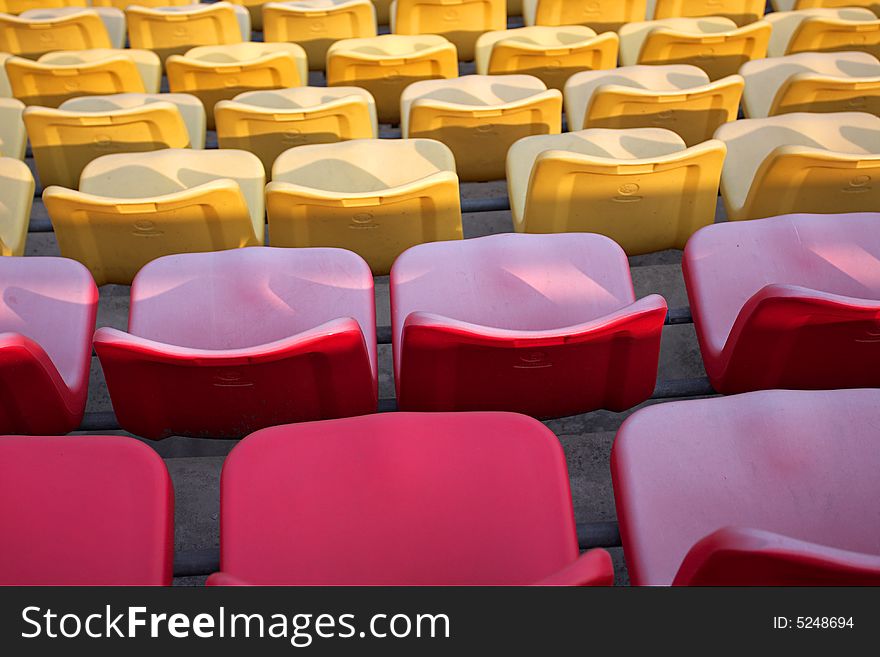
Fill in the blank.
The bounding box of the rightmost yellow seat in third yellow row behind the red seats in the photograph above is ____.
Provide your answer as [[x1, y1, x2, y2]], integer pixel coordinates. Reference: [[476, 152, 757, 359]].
[[767, 7, 880, 57]]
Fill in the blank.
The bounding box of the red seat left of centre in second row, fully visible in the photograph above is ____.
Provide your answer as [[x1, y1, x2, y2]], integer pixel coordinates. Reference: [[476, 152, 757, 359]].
[[95, 247, 378, 439]]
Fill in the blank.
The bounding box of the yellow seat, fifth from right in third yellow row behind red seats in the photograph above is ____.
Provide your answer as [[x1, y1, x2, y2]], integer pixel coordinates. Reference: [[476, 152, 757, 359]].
[[165, 43, 309, 129]]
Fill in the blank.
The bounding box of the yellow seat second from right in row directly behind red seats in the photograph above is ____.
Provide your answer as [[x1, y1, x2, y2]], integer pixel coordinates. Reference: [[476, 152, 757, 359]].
[[507, 128, 726, 255]]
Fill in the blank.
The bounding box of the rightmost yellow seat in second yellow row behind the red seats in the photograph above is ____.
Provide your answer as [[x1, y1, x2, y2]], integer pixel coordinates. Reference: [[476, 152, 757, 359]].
[[740, 52, 880, 119]]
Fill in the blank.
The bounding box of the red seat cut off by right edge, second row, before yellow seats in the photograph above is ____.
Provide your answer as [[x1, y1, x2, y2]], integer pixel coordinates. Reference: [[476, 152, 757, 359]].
[[682, 213, 880, 394]]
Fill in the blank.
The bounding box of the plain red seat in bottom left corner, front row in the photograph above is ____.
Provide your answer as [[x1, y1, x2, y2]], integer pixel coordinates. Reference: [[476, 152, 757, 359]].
[[0, 436, 174, 586]]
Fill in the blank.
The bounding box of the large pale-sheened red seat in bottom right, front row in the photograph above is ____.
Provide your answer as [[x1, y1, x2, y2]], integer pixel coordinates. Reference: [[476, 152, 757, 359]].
[[611, 390, 880, 586]]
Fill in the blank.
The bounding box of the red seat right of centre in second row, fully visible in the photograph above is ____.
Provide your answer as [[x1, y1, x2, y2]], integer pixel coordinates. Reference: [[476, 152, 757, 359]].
[[391, 233, 666, 417]]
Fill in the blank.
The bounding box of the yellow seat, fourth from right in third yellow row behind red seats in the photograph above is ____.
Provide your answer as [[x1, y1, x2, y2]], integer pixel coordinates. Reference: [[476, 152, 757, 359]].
[[327, 34, 458, 123]]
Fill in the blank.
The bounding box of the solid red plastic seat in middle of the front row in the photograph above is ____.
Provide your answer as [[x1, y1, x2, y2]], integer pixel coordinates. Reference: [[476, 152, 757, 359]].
[[208, 413, 613, 585]]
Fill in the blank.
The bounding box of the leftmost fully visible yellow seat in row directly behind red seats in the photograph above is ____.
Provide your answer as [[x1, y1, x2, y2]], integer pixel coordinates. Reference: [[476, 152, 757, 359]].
[[43, 149, 265, 285]]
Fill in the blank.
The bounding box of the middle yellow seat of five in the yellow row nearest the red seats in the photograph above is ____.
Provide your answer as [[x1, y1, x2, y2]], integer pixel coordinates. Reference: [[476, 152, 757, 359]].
[[266, 139, 462, 274]]
